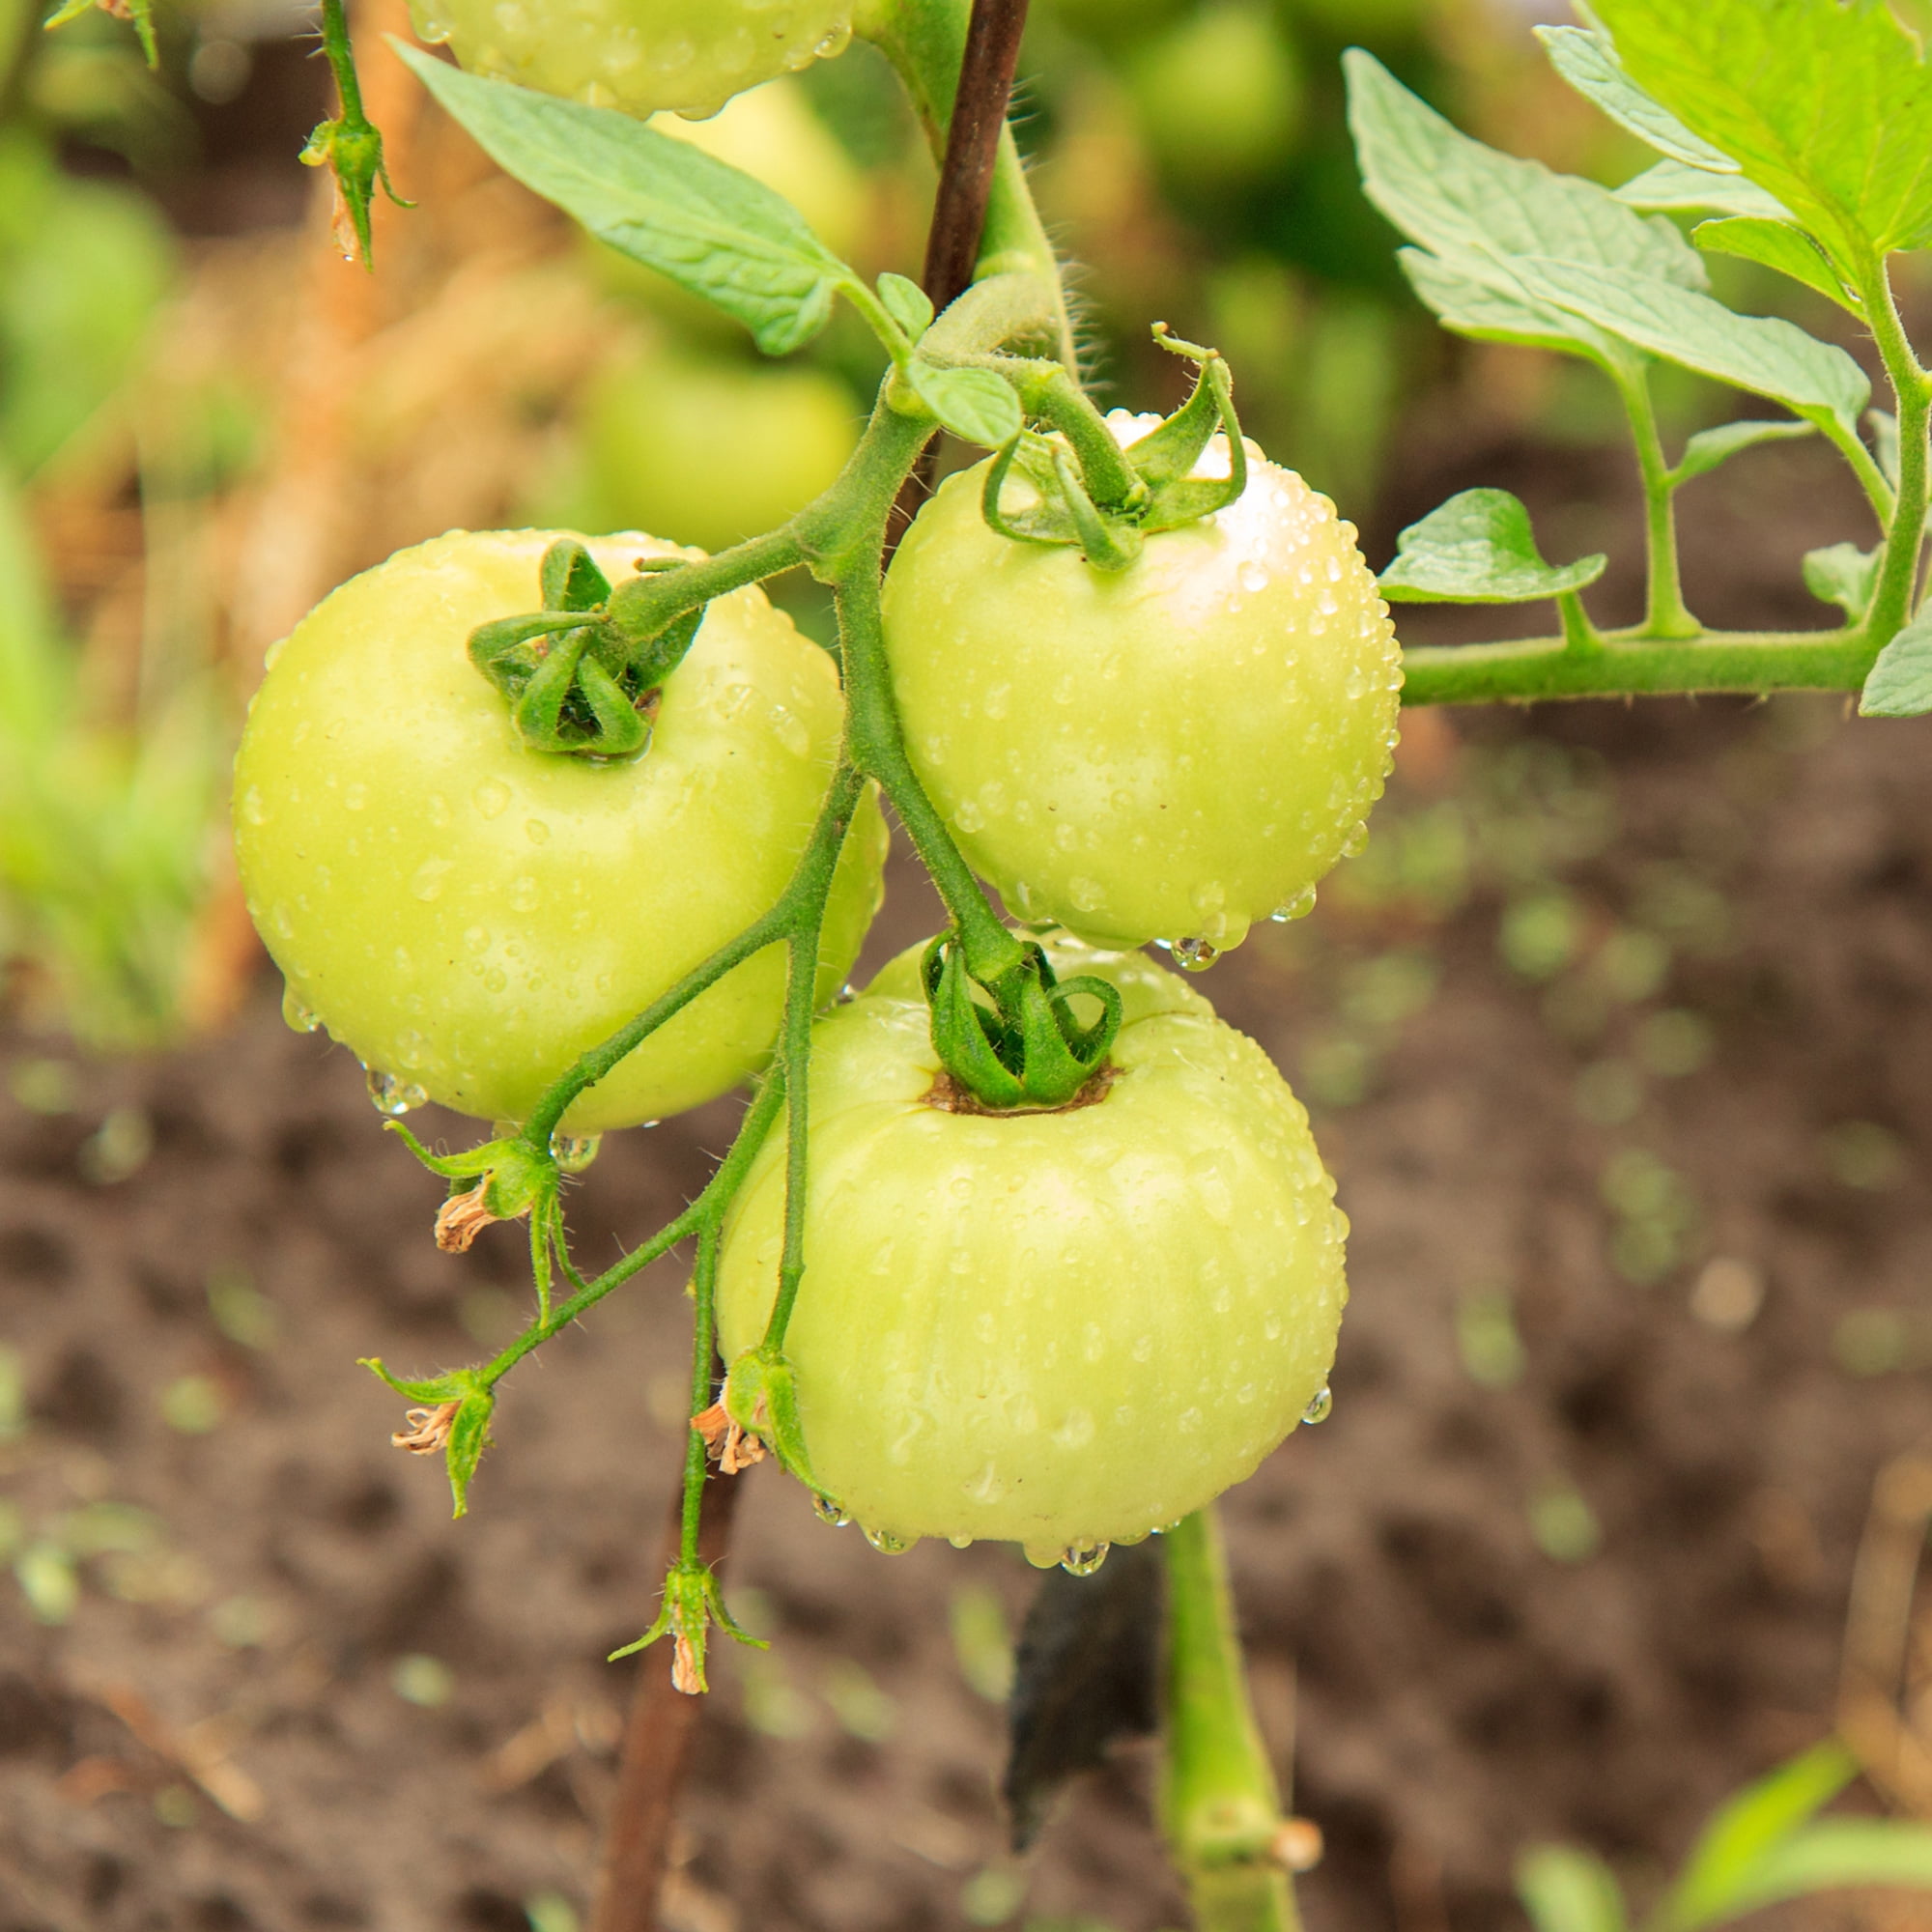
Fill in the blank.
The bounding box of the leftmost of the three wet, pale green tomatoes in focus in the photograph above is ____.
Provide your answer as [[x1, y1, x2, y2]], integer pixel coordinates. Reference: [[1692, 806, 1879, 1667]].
[[234, 529, 885, 1134]]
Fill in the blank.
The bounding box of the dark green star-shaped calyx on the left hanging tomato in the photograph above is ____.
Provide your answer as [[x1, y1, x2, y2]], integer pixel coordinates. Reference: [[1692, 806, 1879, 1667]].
[[469, 537, 705, 759]]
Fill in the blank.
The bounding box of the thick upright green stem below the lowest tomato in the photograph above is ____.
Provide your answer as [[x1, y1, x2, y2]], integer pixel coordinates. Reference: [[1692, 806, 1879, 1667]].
[[1161, 1503, 1298, 1932]]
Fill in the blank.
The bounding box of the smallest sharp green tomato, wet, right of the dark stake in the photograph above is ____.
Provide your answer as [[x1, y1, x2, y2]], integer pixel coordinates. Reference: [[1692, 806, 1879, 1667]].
[[885, 412, 1403, 958]]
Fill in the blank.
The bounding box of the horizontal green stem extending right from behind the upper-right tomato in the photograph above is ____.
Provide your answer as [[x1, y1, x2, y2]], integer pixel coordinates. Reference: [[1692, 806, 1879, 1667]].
[[1403, 630, 1876, 705]]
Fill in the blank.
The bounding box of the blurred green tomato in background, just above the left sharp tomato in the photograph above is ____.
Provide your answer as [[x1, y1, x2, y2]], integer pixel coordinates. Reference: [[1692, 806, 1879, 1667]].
[[578, 357, 860, 551]]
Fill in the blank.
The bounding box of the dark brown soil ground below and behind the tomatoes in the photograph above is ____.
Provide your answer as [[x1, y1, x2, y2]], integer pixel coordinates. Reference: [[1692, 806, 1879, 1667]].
[[0, 653, 1932, 1932]]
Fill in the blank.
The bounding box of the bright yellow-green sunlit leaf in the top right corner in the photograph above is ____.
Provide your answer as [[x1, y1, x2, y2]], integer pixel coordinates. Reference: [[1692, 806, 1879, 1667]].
[[1598, 0, 1932, 261]]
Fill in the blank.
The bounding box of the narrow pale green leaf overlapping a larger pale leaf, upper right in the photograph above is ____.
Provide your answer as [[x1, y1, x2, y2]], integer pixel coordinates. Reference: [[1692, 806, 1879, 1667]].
[[1515, 259, 1872, 439]]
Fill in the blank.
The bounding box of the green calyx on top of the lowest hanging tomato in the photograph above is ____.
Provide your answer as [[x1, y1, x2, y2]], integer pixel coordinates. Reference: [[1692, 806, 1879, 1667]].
[[920, 931, 1122, 1113]]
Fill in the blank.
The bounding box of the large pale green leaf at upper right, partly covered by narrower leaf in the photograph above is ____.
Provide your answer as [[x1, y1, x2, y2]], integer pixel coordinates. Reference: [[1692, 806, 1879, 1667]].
[[1343, 48, 1708, 365]]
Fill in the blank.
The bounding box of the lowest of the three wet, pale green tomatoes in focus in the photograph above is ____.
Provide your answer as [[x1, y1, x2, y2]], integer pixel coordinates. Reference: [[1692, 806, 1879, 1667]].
[[719, 935, 1347, 1563]]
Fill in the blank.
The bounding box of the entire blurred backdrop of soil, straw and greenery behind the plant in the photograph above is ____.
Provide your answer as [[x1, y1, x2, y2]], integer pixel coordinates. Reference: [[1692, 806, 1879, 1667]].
[[0, 0, 1932, 1932]]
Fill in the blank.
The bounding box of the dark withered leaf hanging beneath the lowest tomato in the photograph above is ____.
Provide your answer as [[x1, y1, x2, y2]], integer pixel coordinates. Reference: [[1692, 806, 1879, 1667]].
[[1001, 1544, 1161, 1851]]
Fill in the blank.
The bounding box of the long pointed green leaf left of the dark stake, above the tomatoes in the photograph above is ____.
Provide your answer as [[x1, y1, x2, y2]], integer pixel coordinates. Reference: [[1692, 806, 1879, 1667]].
[[390, 41, 856, 355]]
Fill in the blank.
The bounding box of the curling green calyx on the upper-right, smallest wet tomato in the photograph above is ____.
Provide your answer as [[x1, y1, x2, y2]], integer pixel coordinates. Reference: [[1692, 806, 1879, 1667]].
[[980, 323, 1248, 570]]
